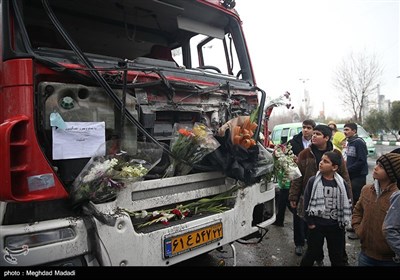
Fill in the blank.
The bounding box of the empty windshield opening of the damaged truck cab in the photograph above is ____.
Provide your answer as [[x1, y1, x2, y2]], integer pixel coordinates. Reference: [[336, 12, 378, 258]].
[[17, 0, 252, 80]]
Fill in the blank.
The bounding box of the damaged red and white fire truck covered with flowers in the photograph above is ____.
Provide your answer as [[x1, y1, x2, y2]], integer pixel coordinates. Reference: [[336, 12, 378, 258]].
[[0, 0, 275, 266]]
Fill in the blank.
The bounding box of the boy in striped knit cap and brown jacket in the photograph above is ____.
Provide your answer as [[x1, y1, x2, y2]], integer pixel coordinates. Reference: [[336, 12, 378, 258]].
[[351, 153, 400, 266]]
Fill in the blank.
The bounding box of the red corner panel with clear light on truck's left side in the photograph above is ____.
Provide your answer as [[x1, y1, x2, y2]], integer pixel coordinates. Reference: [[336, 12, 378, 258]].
[[0, 115, 68, 201]]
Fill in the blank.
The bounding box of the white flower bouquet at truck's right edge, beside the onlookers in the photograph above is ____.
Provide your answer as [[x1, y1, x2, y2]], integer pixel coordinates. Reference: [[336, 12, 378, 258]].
[[273, 143, 301, 188]]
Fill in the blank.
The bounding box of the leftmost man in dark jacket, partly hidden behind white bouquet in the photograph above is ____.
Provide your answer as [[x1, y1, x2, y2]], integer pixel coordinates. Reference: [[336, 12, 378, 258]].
[[274, 119, 316, 256]]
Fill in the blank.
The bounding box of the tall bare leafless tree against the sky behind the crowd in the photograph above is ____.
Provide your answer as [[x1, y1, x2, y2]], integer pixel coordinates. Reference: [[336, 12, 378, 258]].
[[333, 53, 383, 123]]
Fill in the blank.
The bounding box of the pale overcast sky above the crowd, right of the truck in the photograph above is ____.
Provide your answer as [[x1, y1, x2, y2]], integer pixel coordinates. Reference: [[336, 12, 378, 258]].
[[235, 0, 400, 117]]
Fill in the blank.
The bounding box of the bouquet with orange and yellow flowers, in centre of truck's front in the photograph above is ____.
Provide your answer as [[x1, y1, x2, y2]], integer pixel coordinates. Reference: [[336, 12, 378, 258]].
[[164, 123, 220, 177]]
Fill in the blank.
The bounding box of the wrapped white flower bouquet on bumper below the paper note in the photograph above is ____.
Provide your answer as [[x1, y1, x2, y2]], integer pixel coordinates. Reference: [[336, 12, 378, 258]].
[[70, 141, 161, 204]]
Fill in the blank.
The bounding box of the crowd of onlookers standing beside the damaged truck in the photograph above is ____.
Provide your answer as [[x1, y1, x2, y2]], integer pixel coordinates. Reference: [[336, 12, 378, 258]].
[[274, 119, 400, 266]]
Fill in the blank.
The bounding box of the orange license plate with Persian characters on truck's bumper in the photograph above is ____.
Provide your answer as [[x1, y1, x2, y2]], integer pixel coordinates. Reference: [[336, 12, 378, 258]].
[[164, 222, 223, 258]]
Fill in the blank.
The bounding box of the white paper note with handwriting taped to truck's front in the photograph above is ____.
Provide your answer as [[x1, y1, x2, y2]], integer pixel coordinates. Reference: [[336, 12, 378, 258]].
[[53, 122, 106, 159]]
